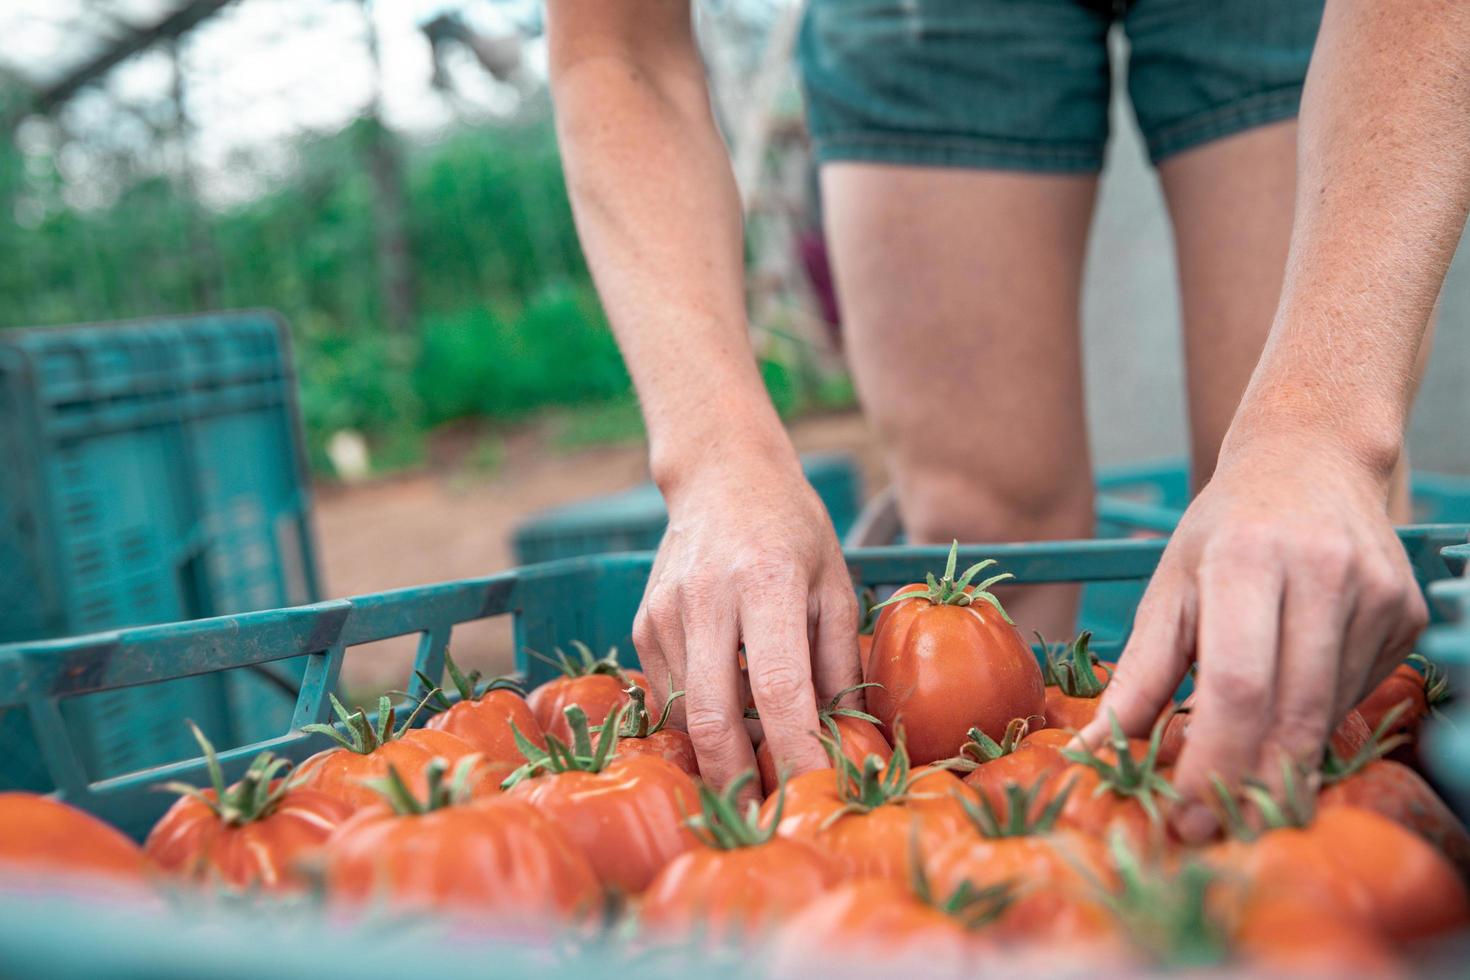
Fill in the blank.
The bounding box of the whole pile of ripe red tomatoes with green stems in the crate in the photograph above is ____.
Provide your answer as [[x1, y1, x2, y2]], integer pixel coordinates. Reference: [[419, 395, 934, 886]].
[[0, 552, 1470, 976]]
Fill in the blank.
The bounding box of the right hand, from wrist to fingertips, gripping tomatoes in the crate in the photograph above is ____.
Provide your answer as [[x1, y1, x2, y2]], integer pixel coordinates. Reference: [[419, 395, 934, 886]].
[[1082, 430, 1429, 842]]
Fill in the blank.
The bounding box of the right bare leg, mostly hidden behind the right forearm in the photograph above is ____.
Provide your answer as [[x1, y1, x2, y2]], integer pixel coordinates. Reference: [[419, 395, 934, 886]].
[[1158, 120, 1429, 522]]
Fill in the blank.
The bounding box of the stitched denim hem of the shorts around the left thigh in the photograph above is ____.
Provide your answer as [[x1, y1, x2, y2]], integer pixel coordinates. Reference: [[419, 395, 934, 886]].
[[813, 132, 1103, 173]]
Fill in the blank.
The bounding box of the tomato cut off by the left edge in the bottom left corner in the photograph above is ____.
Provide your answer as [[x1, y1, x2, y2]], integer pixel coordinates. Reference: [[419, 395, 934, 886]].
[[0, 792, 148, 883]]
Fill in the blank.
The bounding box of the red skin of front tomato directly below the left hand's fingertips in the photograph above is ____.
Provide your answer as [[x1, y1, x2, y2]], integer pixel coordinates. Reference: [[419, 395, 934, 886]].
[[638, 837, 842, 945]]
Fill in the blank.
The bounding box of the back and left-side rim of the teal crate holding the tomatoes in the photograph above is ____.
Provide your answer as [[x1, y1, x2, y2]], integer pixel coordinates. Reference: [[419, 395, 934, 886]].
[[0, 526, 1470, 837]]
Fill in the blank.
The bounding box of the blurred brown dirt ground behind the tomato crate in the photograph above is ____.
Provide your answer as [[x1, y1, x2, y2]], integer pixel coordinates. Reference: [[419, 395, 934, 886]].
[[316, 413, 883, 696]]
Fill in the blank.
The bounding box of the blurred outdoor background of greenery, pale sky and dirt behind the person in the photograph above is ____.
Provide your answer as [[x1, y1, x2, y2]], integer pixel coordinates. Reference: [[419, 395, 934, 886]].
[[0, 0, 1470, 691]]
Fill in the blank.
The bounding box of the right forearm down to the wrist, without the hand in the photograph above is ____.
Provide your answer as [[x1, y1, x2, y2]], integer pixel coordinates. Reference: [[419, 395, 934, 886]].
[[1226, 0, 1470, 479]]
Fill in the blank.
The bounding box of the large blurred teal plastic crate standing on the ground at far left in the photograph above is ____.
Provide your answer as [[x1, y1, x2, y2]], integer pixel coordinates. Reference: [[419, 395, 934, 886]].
[[0, 311, 319, 789]]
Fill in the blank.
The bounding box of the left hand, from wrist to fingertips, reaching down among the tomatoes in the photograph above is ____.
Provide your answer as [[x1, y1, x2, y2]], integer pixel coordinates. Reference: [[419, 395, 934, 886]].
[[634, 454, 860, 795]]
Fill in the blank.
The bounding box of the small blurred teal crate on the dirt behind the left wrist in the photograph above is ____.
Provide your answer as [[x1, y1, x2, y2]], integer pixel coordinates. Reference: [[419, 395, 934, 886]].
[[512, 453, 863, 566]]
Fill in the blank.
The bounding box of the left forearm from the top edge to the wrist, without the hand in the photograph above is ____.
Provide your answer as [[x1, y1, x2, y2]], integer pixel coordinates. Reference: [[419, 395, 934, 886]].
[[551, 0, 795, 492]]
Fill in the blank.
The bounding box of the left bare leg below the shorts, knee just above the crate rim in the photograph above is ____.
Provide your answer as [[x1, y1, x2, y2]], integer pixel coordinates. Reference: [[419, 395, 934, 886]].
[[822, 163, 1097, 638]]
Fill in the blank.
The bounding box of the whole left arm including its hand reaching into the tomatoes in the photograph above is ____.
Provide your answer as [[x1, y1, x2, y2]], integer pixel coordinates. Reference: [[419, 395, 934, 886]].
[[548, 0, 857, 785]]
